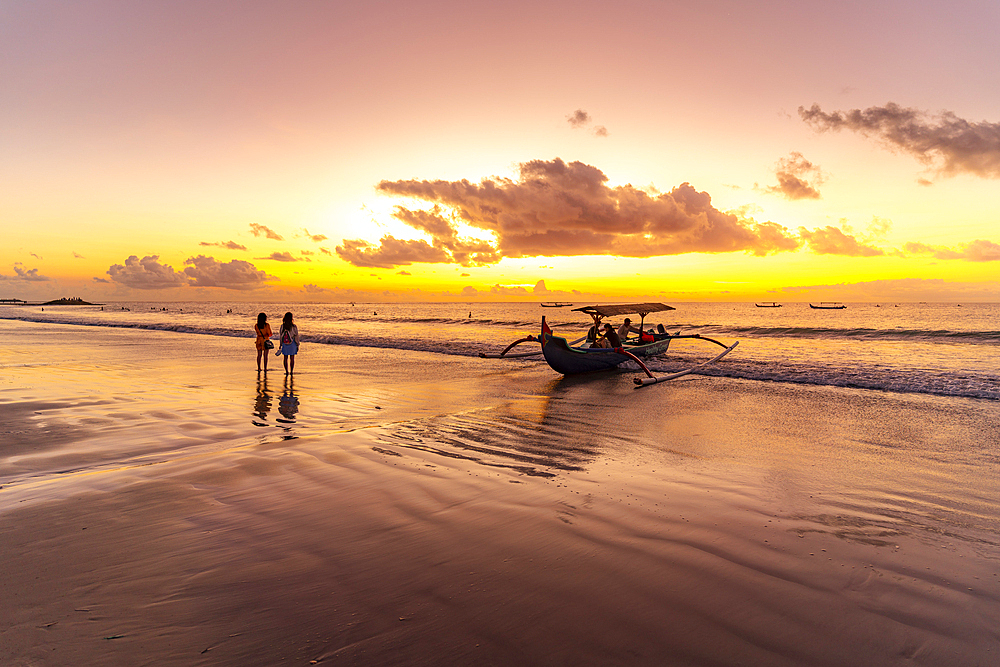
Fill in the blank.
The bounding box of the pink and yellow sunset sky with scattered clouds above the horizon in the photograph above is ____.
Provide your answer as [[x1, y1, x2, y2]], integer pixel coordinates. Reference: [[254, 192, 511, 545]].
[[0, 0, 1000, 303]]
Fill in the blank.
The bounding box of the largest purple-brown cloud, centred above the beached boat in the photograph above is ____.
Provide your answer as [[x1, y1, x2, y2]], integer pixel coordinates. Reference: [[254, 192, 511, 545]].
[[348, 158, 801, 268]]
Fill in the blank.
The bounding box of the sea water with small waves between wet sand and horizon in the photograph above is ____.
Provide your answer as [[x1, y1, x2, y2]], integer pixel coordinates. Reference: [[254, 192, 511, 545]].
[[0, 301, 1000, 400]]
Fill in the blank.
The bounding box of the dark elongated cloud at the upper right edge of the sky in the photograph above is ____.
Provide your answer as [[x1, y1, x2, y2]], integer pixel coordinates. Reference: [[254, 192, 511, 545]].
[[799, 102, 1000, 178]]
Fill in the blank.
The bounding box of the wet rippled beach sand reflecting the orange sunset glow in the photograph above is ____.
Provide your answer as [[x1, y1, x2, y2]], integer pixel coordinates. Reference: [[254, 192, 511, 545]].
[[0, 322, 1000, 666]]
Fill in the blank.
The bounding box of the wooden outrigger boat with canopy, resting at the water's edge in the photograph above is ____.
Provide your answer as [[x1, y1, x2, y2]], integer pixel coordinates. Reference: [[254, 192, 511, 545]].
[[479, 303, 739, 387]]
